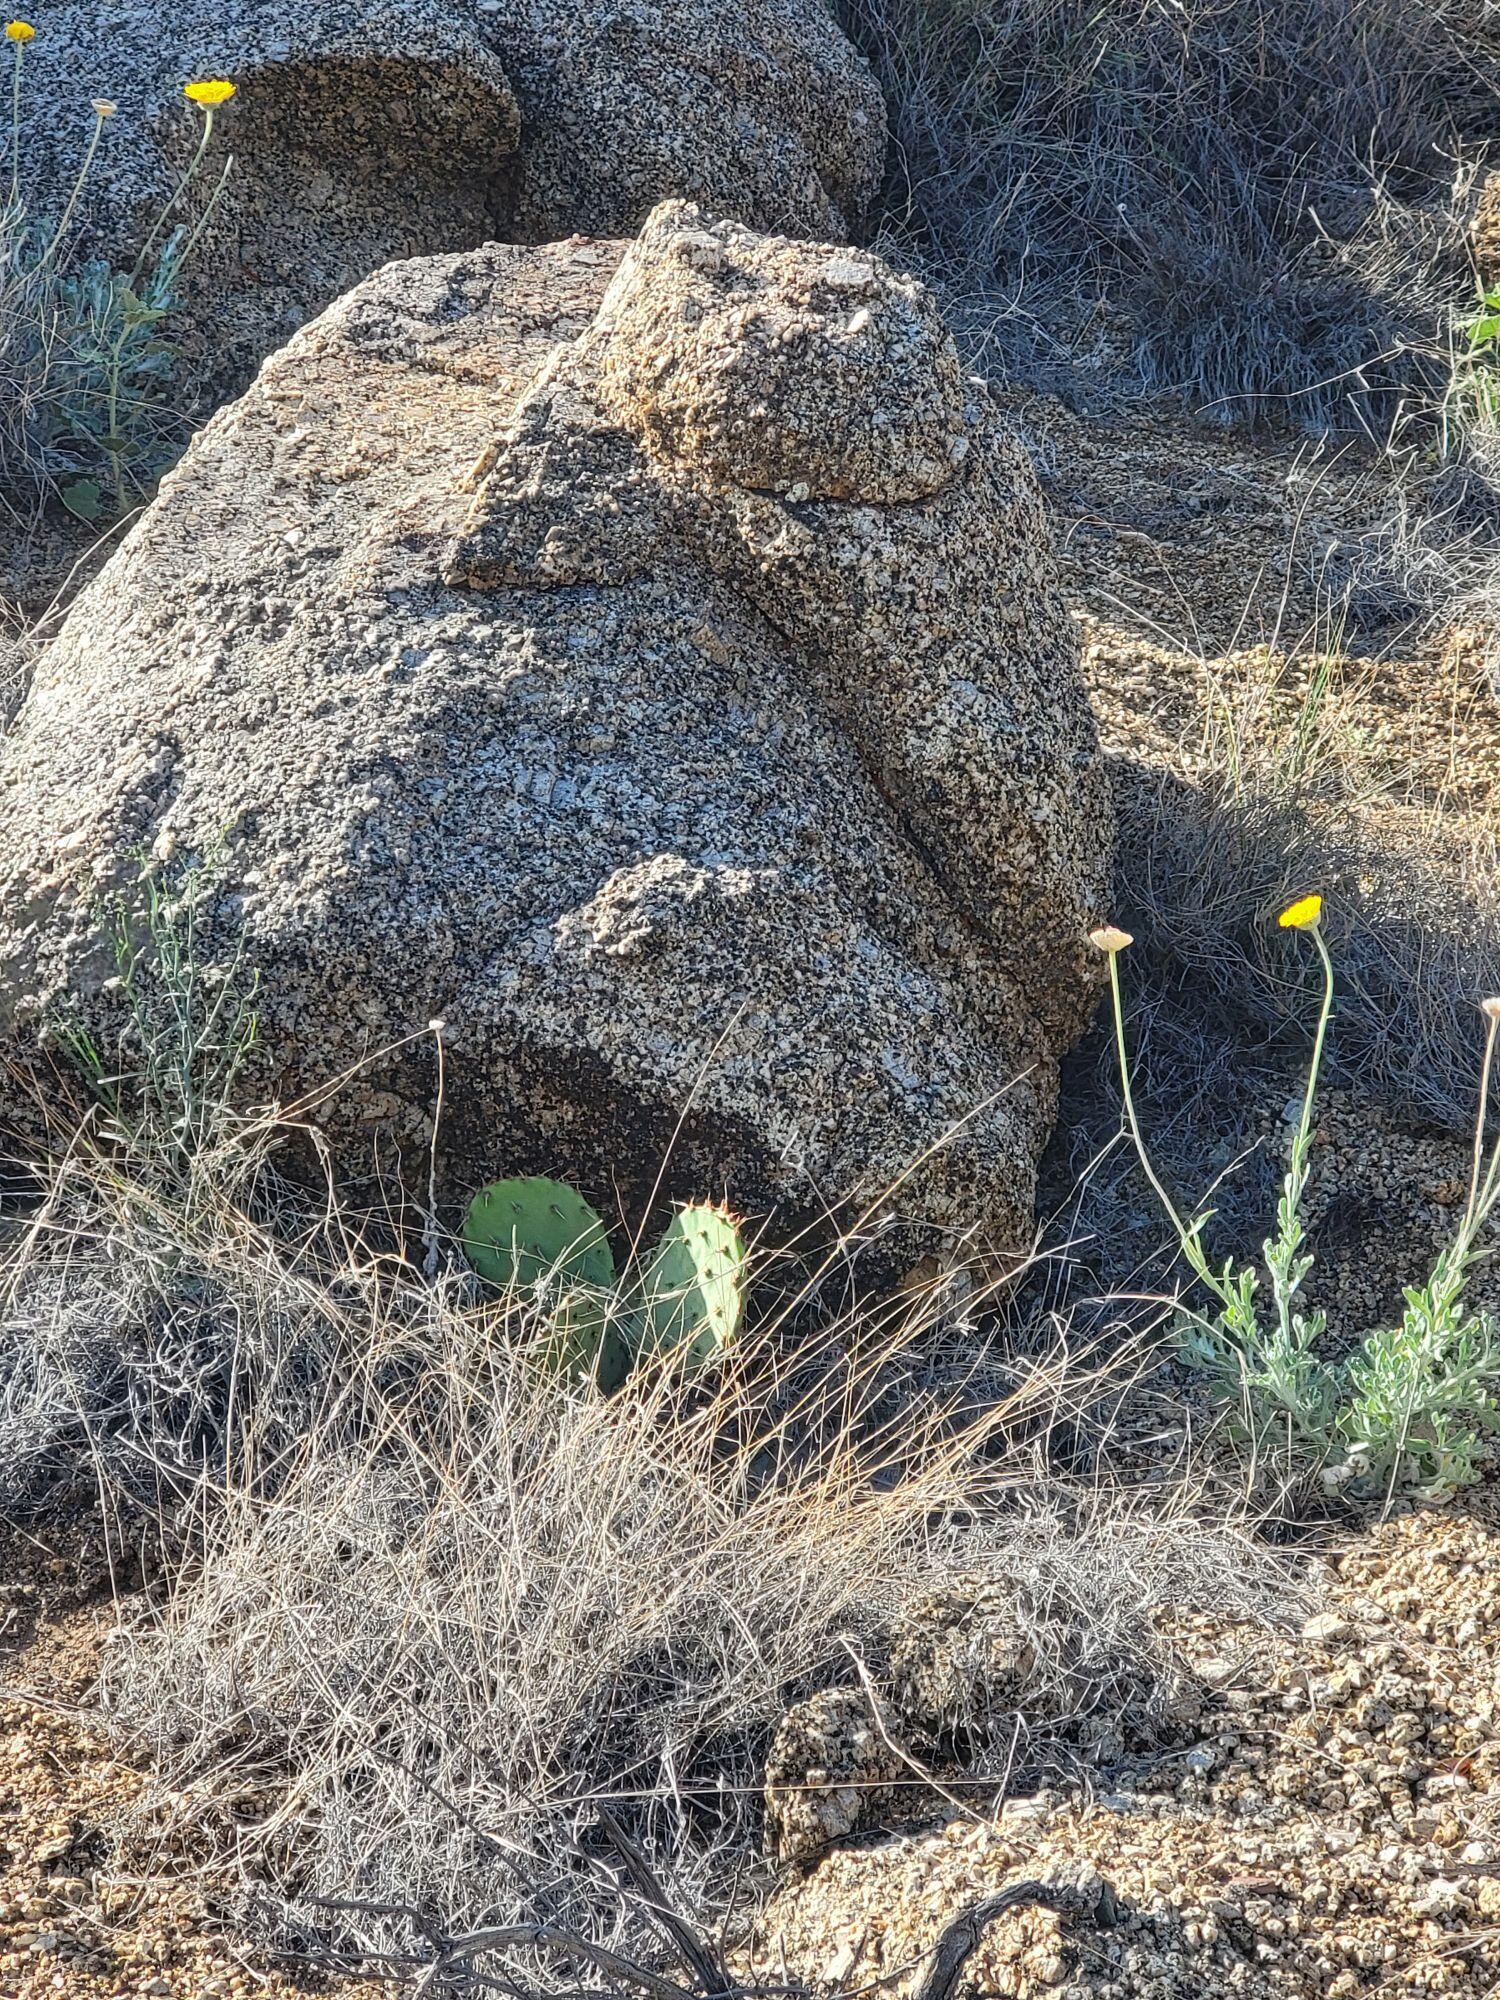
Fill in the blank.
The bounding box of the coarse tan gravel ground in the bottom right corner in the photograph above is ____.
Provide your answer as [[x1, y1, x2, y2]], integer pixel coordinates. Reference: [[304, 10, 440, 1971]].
[[758, 1490, 1500, 2000]]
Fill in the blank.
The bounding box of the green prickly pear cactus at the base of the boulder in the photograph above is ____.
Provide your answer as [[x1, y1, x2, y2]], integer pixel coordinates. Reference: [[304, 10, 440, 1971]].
[[462, 1178, 746, 1394]]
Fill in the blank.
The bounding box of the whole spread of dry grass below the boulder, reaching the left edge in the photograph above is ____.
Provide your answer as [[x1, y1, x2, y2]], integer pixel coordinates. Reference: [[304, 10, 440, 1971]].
[[0, 1120, 1296, 1990]]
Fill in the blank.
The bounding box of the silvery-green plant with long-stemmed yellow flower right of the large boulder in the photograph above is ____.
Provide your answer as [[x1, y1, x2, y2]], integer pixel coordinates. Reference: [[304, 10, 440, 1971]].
[[1092, 896, 1500, 1498]]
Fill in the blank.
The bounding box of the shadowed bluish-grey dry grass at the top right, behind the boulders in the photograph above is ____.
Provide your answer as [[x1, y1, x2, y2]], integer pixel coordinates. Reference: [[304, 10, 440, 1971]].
[[840, 0, 1500, 434]]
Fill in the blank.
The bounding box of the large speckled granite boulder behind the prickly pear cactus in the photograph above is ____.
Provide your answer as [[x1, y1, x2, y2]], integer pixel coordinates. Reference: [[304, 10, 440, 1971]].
[[0, 204, 1110, 1248]]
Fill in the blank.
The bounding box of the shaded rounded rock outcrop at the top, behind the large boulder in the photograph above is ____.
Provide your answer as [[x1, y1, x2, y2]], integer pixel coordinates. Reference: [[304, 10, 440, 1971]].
[[20, 0, 886, 396]]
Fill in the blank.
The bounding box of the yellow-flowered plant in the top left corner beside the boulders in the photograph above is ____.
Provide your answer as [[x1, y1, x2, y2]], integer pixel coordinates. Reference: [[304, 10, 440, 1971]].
[[0, 22, 234, 522]]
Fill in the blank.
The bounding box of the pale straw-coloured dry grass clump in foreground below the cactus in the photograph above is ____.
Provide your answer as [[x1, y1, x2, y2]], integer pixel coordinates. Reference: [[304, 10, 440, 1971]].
[[97, 1248, 1296, 1986]]
